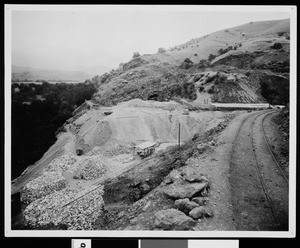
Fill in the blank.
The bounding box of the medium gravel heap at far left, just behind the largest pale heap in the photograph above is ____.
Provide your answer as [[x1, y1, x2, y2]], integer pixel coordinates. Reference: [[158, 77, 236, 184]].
[[21, 171, 66, 203]]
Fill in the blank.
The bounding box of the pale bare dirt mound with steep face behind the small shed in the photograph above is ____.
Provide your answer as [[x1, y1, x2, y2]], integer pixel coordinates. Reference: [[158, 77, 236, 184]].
[[76, 99, 223, 151]]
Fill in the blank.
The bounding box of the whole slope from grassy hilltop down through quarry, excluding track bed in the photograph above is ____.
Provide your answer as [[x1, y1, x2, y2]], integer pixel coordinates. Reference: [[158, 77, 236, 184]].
[[12, 20, 290, 230]]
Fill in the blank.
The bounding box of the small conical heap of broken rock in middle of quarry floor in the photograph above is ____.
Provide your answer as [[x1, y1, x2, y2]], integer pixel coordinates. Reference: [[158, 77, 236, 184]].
[[73, 156, 106, 180]]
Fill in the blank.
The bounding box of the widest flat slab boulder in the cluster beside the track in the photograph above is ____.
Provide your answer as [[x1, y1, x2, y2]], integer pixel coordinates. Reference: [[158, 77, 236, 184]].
[[163, 183, 207, 199]]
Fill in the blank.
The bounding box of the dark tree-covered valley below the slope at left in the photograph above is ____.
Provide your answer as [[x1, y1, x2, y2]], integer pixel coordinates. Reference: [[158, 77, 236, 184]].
[[11, 82, 96, 179]]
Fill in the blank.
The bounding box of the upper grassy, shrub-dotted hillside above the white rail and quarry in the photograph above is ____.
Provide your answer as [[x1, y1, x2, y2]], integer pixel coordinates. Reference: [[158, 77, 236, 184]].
[[91, 17, 289, 106]]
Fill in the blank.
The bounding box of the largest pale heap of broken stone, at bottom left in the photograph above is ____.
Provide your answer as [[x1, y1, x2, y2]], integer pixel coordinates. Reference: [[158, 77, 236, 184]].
[[23, 186, 104, 230]]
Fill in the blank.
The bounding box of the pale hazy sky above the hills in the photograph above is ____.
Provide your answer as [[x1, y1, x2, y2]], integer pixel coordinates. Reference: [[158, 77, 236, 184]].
[[12, 5, 289, 70]]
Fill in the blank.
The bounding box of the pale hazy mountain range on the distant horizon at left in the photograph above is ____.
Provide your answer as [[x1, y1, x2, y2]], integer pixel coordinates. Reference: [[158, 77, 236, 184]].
[[12, 65, 111, 82]]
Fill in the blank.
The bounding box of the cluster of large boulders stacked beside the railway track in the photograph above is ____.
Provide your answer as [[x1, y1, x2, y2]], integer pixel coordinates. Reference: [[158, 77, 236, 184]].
[[155, 168, 213, 230]]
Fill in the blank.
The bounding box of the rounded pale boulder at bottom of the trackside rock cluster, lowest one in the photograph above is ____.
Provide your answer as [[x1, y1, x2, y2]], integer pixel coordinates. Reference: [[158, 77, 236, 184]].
[[154, 209, 196, 230]]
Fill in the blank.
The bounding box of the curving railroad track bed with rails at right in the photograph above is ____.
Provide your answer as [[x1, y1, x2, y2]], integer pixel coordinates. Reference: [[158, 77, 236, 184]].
[[230, 111, 288, 230]]
